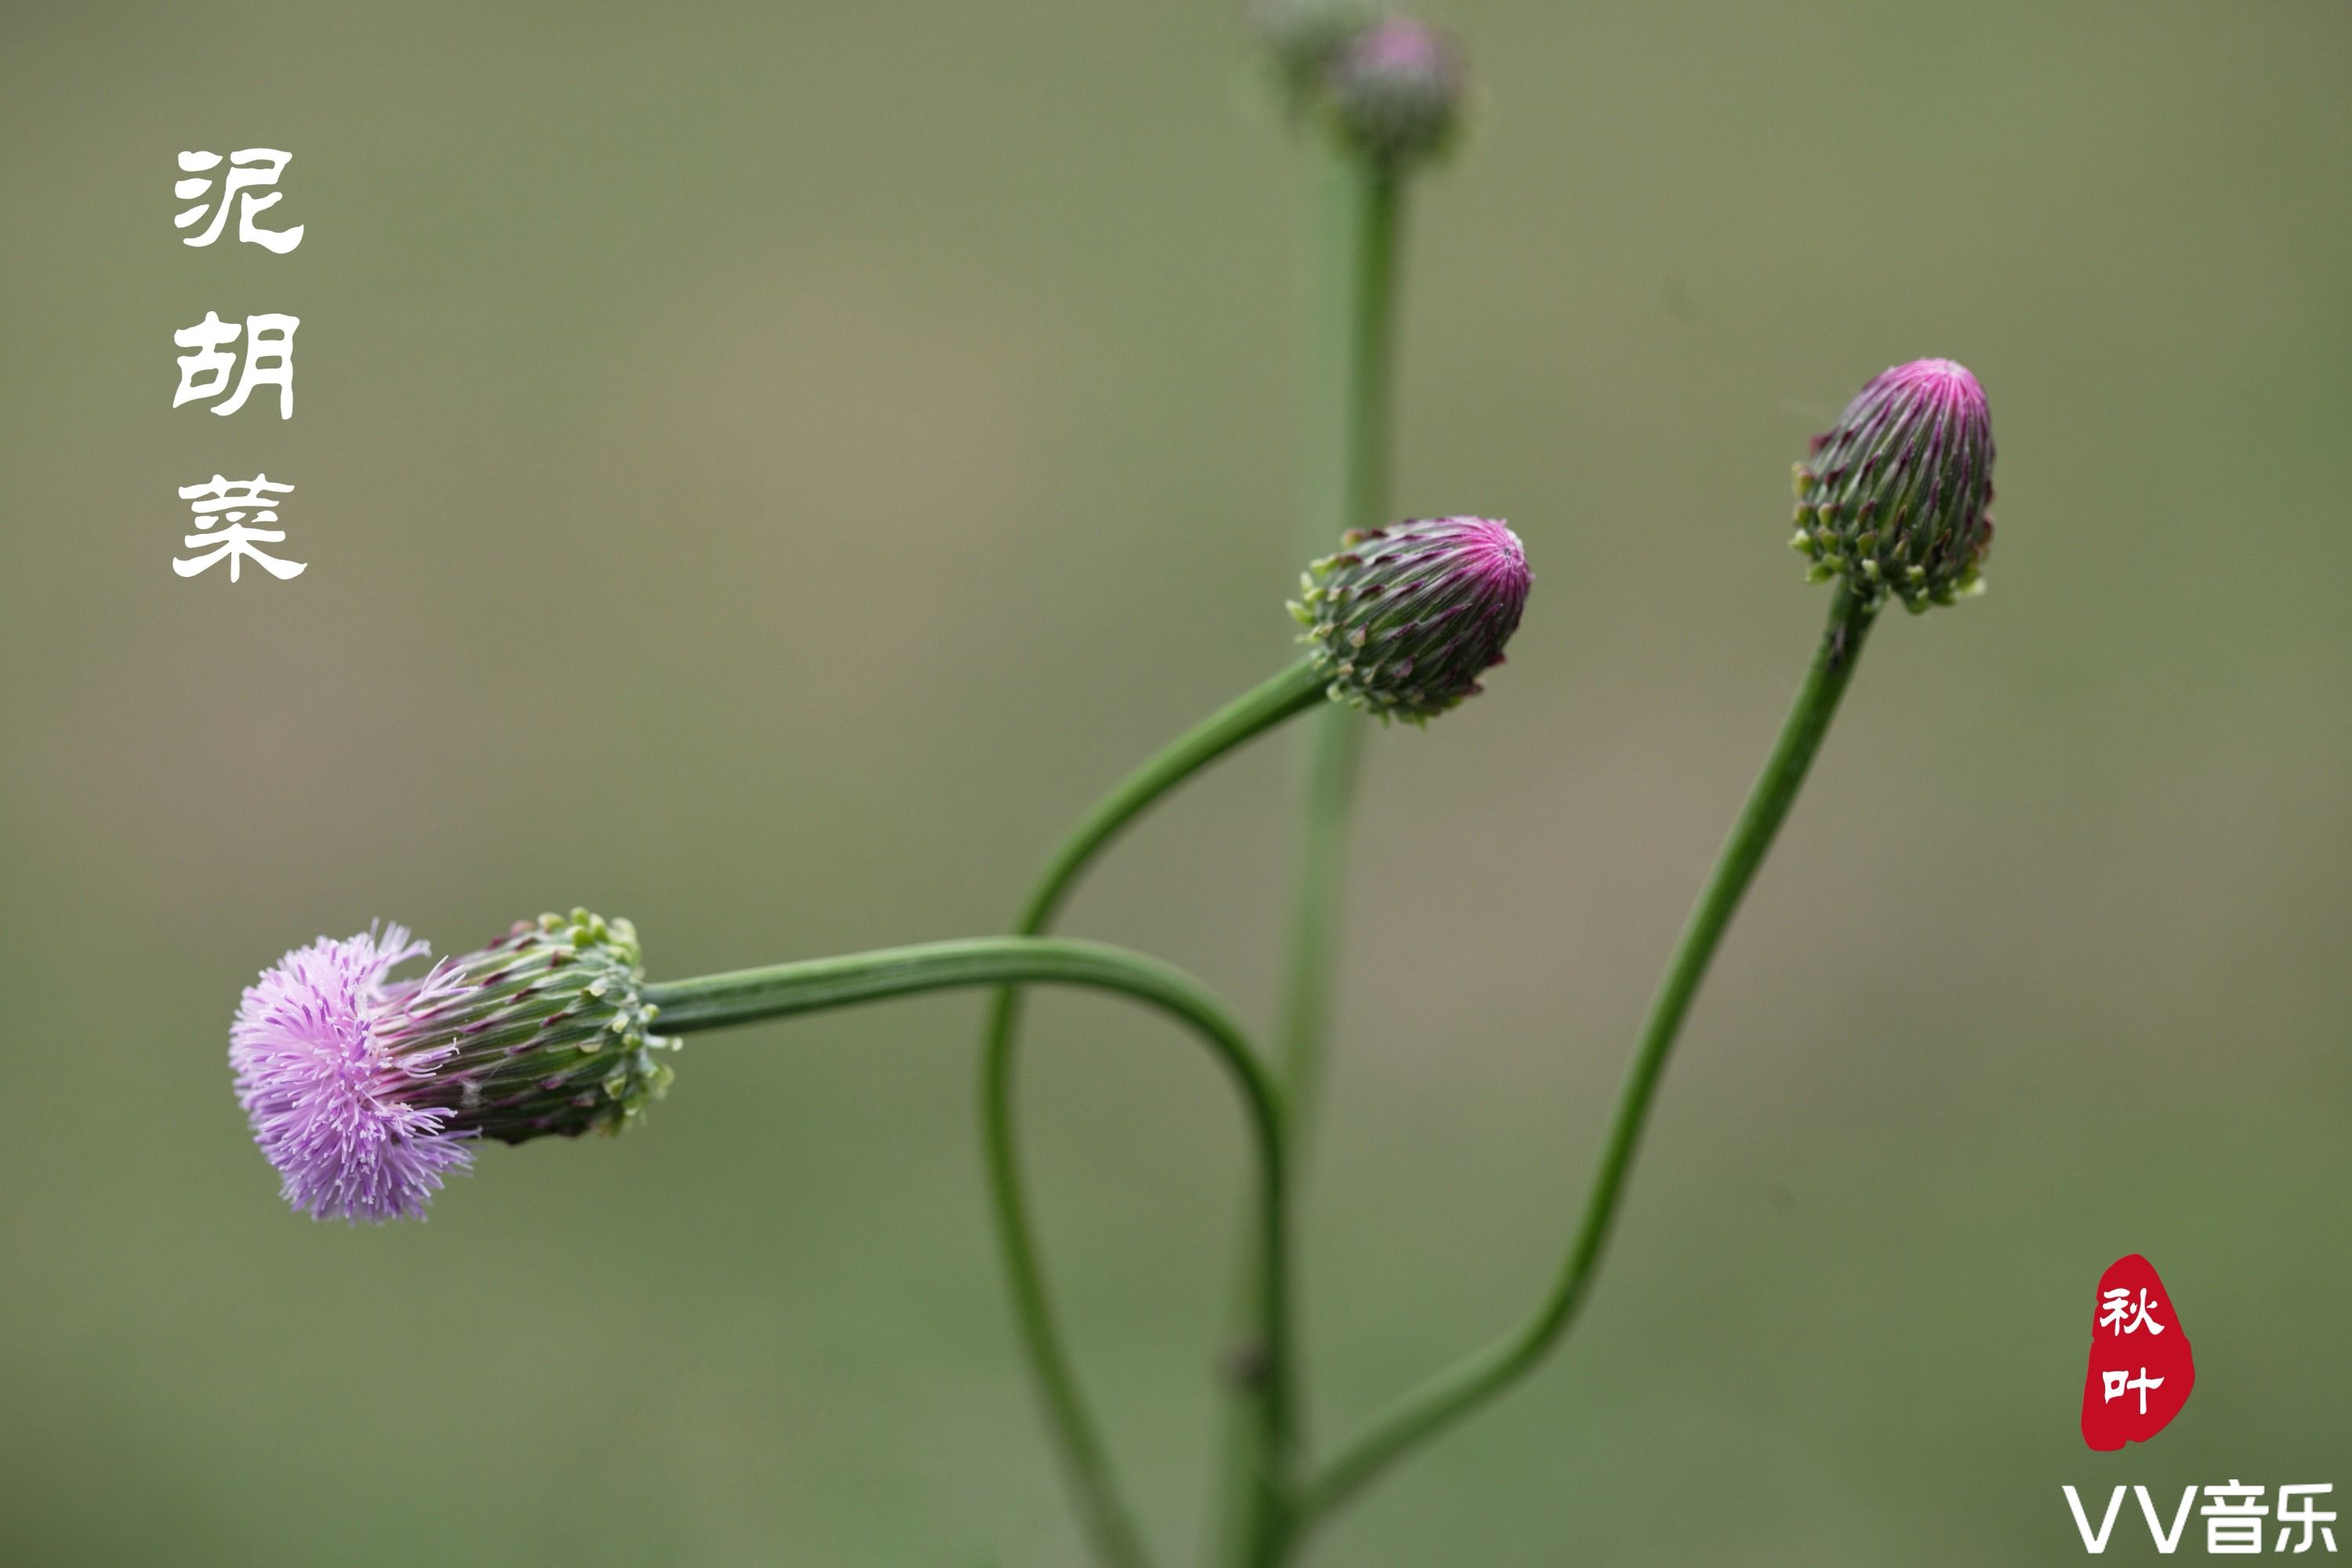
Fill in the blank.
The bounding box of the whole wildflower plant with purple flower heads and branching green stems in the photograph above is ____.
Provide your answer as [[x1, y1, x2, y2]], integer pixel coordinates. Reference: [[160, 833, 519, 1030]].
[[228, 0, 1992, 1568]]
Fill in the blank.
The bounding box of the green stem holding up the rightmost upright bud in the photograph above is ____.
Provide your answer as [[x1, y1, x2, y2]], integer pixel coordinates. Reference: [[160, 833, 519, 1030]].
[[1301, 581, 1875, 1519]]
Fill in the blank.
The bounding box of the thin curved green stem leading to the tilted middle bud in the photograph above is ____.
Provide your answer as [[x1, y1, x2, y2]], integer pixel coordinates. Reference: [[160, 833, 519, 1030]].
[[981, 661, 1324, 1568]]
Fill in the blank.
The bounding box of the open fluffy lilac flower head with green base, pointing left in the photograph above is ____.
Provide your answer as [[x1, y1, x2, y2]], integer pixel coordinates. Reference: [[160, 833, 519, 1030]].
[[228, 909, 675, 1220]]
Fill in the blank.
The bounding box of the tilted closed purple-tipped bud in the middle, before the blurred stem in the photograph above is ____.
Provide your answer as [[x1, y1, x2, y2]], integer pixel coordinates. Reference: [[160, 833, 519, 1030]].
[[1291, 517, 1534, 724]]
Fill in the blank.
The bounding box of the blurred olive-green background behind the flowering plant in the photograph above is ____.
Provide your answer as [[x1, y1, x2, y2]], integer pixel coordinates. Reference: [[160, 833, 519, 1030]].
[[0, 0, 2352, 1568]]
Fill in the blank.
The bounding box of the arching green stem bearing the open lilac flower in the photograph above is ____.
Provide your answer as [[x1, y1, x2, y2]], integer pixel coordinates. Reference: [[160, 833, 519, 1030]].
[[644, 935, 1291, 1561]]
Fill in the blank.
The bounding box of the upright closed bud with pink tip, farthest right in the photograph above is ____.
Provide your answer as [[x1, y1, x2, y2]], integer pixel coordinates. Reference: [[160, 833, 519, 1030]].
[[1790, 360, 1992, 612]]
